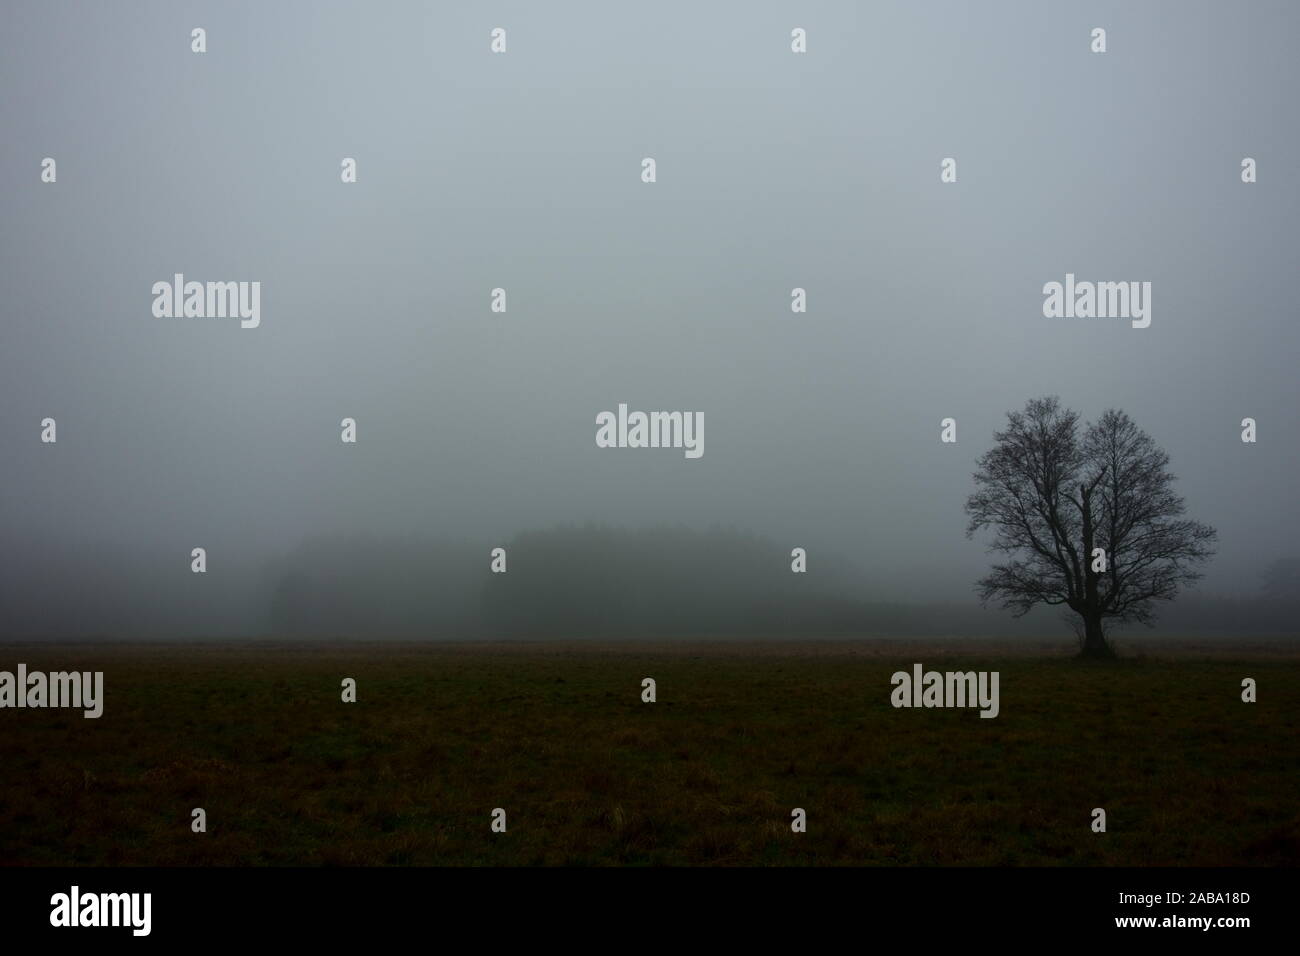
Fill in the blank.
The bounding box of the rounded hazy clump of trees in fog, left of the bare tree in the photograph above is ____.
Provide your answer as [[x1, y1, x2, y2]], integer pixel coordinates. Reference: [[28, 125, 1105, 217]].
[[270, 525, 853, 637]]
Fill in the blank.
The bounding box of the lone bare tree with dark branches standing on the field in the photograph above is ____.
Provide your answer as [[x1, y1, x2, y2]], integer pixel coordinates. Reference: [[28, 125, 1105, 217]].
[[966, 397, 1217, 657]]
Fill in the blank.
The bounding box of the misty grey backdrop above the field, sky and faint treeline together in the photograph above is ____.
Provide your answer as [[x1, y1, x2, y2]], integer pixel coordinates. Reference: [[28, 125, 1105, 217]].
[[0, 0, 1300, 637]]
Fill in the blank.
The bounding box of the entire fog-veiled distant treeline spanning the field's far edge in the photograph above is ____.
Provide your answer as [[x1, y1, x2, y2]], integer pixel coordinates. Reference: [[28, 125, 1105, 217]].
[[0, 524, 1300, 640]]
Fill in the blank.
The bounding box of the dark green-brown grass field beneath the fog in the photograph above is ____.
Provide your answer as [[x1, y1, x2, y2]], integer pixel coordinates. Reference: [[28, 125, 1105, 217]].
[[0, 641, 1300, 866]]
